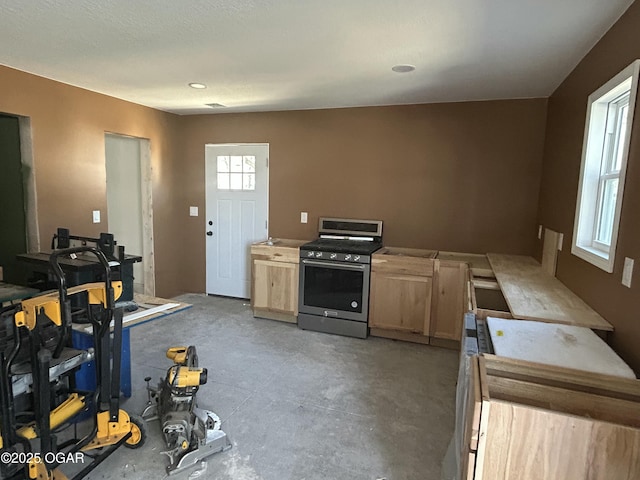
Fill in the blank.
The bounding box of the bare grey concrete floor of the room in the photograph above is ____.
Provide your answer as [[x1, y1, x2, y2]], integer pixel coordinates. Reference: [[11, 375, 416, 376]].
[[81, 295, 458, 480]]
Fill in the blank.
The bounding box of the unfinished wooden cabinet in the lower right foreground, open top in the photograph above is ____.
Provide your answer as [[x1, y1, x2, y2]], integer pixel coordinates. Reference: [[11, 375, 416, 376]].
[[455, 355, 640, 480]]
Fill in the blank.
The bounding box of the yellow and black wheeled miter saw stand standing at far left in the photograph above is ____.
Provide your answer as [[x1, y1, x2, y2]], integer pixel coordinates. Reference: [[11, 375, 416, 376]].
[[0, 247, 146, 480]]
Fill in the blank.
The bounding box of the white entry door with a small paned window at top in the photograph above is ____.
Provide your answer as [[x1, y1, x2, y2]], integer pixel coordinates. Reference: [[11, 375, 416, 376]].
[[205, 144, 269, 298]]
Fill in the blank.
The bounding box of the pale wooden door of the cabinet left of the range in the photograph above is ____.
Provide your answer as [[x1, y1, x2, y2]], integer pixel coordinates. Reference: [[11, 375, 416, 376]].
[[251, 259, 298, 315]]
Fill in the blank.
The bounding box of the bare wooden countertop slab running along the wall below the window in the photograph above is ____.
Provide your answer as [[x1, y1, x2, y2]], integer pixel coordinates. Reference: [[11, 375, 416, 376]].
[[487, 253, 613, 331]]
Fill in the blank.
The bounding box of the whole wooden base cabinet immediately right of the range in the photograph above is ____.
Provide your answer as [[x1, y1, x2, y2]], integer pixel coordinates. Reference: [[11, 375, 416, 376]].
[[369, 248, 436, 343]]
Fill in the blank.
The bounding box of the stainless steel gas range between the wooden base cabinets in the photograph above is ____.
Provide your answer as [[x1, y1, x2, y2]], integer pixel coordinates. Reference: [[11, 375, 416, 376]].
[[298, 217, 382, 338]]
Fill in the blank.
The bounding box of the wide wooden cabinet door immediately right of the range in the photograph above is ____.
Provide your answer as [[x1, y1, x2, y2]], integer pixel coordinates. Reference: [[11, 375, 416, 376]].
[[369, 272, 432, 335]]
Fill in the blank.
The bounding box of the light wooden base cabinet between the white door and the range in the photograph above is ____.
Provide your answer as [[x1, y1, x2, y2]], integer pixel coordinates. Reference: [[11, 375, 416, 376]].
[[251, 240, 304, 323]]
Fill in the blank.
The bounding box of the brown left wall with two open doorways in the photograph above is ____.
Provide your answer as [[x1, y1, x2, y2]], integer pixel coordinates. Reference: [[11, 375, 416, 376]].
[[0, 66, 179, 295]]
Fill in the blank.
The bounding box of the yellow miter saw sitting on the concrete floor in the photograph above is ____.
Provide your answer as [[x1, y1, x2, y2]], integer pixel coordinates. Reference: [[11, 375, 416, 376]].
[[142, 346, 231, 474]]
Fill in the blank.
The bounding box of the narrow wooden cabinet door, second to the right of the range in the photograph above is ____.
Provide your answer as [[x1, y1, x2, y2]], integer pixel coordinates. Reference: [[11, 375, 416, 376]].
[[431, 260, 468, 341]]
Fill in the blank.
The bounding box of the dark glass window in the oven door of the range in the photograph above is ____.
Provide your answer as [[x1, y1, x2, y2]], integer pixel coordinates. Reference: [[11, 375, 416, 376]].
[[303, 264, 365, 313]]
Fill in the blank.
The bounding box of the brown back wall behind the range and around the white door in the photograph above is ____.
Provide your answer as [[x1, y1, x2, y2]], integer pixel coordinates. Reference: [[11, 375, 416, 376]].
[[175, 99, 546, 292]]
